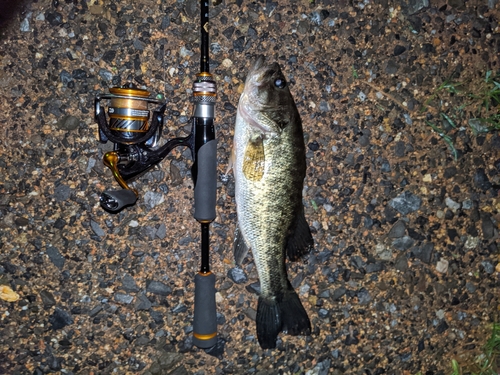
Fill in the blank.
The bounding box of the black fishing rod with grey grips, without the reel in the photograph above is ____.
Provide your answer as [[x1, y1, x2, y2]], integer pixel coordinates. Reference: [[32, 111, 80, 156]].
[[192, 0, 217, 348]]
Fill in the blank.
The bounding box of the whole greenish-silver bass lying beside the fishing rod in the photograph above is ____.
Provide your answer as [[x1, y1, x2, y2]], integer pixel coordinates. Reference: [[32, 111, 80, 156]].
[[231, 56, 314, 349]]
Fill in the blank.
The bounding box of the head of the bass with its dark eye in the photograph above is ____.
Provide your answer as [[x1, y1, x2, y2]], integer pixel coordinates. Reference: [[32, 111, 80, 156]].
[[238, 56, 297, 134]]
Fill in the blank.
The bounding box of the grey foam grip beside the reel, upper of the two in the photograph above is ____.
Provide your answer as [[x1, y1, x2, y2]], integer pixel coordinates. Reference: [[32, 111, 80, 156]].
[[194, 139, 217, 222]]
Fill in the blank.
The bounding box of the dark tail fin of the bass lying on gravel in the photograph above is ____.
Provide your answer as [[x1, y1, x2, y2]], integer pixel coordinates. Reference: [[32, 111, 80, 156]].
[[256, 289, 311, 349]]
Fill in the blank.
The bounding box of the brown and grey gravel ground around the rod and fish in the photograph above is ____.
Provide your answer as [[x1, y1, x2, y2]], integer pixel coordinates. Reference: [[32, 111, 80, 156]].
[[0, 0, 500, 375]]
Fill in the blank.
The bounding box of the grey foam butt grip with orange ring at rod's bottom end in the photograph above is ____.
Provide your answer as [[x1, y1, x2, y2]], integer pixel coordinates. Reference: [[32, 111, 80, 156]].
[[193, 273, 217, 349]]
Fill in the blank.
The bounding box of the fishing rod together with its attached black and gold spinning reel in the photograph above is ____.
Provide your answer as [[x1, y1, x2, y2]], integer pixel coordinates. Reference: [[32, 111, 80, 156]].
[[94, 0, 217, 348]]
